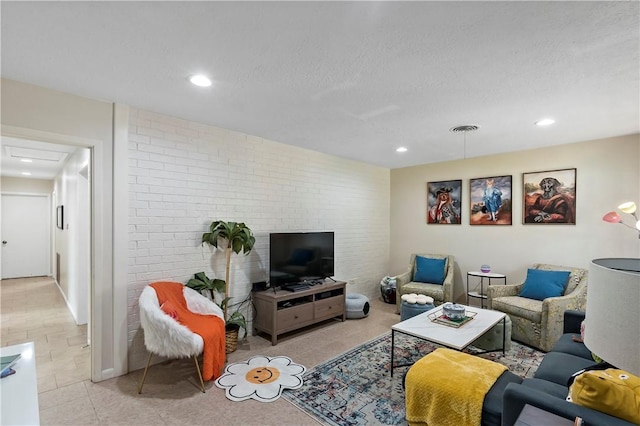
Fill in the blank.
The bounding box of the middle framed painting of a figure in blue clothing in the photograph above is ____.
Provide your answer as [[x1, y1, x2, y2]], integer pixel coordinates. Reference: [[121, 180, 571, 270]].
[[469, 175, 512, 225]]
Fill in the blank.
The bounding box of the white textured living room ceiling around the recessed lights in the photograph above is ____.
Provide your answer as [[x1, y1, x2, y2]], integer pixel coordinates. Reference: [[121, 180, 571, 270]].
[[1, 1, 640, 168]]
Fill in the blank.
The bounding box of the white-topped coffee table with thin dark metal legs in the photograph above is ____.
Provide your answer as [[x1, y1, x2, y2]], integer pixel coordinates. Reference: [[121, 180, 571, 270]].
[[391, 306, 507, 377]]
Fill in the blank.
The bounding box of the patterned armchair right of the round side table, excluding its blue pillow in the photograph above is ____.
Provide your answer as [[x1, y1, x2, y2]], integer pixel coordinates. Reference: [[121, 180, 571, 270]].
[[487, 264, 588, 352]]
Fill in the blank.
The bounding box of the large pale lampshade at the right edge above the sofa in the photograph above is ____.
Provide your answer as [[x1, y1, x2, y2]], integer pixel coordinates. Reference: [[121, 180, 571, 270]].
[[584, 258, 640, 376]]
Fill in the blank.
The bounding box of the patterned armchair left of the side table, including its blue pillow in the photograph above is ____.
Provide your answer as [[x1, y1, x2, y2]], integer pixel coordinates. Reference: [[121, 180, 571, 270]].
[[396, 253, 455, 313]]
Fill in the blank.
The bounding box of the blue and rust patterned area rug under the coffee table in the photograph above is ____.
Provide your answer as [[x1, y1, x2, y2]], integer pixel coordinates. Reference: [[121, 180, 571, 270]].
[[282, 332, 544, 425]]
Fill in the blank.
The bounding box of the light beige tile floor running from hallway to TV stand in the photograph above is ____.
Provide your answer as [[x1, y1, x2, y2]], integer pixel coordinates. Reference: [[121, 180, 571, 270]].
[[0, 278, 402, 425]]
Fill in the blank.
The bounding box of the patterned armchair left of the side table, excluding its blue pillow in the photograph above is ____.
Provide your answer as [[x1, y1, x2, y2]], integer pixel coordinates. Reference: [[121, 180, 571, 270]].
[[396, 253, 454, 313]]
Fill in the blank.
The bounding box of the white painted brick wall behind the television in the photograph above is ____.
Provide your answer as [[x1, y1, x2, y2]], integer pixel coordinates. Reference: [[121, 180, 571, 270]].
[[128, 108, 390, 370]]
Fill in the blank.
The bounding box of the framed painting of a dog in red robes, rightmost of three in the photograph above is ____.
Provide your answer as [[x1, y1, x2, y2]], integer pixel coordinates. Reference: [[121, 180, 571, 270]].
[[522, 169, 576, 225]]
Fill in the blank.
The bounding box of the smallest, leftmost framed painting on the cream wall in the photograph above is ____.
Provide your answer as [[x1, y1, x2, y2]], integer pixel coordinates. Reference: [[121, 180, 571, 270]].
[[427, 180, 462, 225]]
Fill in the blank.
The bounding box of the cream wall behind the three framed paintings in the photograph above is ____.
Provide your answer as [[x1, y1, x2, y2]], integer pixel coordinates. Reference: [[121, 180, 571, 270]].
[[389, 135, 640, 301]]
